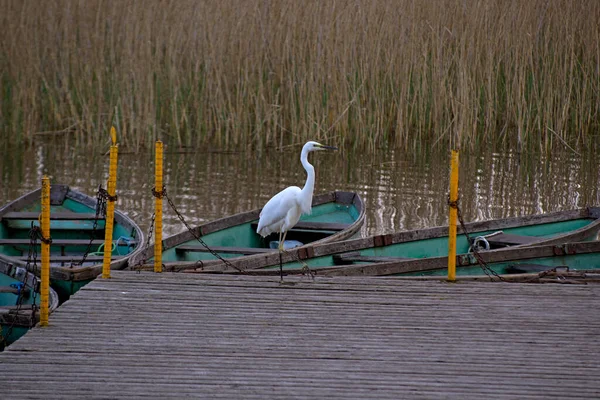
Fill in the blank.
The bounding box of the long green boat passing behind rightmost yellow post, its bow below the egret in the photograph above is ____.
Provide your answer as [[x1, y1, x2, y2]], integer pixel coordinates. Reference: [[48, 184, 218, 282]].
[[183, 207, 600, 275]]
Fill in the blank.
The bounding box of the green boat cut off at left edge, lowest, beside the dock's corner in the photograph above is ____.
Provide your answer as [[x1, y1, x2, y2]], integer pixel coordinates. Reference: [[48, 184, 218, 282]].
[[0, 260, 58, 351]]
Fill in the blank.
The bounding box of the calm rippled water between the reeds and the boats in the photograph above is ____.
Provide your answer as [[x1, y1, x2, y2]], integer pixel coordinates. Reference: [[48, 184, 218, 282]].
[[0, 138, 600, 241]]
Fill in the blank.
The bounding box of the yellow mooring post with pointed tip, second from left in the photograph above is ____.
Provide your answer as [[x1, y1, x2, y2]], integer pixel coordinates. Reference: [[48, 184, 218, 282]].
[[102, 126, 119, 279]]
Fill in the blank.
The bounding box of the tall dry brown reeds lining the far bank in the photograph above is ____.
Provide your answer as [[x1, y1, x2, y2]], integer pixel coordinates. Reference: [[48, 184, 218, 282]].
[[0, 0, 600, 149]]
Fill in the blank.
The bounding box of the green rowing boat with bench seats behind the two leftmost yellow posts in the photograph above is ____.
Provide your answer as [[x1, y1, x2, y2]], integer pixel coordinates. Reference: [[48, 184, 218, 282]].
[[0, 185, 143, 301]]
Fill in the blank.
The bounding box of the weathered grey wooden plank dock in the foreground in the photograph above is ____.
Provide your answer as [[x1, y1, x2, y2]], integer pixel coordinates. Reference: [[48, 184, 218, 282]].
[[0, 272, 600, 400]]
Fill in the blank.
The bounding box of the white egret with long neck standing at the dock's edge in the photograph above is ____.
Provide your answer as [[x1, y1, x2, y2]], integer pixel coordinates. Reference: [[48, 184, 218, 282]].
[[256, 141, 337, 277]]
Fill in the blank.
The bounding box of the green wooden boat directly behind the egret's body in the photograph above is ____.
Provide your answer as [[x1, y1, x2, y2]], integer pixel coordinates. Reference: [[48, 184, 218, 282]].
[[129, 191, 365, 271]]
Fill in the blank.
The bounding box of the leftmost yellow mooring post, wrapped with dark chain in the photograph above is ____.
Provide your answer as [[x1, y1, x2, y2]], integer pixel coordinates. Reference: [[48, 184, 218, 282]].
[[40, 176, 50, 326]]
